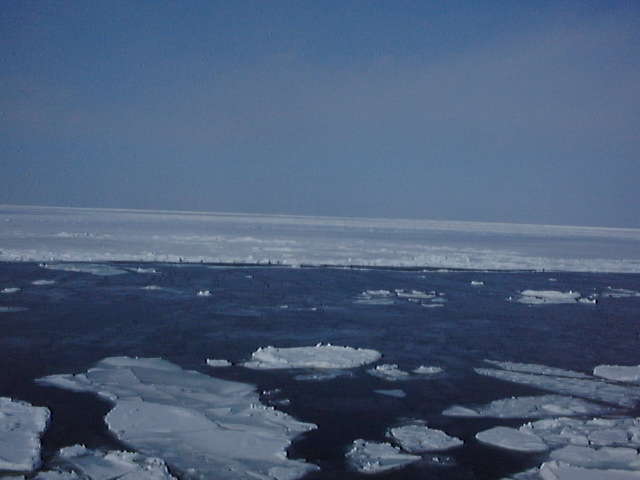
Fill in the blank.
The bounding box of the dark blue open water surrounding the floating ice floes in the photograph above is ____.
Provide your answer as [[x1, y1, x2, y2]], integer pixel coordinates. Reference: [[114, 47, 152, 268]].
[[0, 263, 640, 480]]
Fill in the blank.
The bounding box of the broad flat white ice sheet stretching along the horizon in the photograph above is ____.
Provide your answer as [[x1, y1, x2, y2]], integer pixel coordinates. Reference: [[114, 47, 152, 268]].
[[0, 205, 640, 272]]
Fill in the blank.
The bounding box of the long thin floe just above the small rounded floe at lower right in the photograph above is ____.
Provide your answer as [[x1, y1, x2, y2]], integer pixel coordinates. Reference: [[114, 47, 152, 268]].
[[442, 395, 616, 418]]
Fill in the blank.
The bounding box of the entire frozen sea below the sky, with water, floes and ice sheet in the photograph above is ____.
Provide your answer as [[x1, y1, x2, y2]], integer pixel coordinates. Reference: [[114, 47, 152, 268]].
[[0, 207, 640, 480]]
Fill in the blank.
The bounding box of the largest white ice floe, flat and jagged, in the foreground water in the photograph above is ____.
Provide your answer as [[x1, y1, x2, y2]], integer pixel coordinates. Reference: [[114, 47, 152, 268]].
[[38, 357, 317, 480]]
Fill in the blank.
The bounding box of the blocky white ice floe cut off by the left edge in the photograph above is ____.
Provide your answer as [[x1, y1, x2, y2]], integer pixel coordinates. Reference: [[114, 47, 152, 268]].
[[0, 397, 50, 472]]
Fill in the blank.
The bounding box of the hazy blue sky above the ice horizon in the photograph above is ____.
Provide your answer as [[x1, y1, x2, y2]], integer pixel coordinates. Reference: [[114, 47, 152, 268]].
[[0, 0, 640, 227]]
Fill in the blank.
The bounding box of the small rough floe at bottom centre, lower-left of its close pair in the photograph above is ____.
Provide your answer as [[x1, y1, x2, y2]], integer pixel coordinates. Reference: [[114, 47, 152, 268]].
[[346, 438, 421, 473]]
